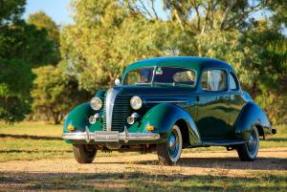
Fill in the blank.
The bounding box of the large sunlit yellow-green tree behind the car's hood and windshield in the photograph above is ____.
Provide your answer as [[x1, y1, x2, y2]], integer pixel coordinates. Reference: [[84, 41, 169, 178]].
[[61, 0, 169, 92]]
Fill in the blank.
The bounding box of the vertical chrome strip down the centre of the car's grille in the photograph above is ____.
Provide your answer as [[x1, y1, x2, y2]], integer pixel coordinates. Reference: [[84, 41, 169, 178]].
[[105, 88, 119, 131]]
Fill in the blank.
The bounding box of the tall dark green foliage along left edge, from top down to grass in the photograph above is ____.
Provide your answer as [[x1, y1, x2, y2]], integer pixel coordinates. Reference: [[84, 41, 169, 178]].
[[0, 0, 60, 122]]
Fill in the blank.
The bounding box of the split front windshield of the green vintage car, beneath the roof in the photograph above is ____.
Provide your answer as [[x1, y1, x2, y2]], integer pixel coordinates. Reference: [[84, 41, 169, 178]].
[[124, 67, 196, 86]]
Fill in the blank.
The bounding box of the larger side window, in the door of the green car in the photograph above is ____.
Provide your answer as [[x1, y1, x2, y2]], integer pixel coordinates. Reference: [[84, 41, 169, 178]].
[[201, 69, 227, 91]]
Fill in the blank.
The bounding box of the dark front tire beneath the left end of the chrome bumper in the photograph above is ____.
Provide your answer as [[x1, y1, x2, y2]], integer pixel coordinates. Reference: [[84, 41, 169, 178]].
[[73, 144, 97, 164]]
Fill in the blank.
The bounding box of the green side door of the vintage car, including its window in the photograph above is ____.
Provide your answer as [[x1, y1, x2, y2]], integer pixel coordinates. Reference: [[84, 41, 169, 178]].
[[196, 68, 230, 141]]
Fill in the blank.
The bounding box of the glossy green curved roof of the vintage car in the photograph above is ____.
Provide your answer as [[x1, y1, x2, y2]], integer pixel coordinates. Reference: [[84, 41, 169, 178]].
[[125, 56, 233, 72]]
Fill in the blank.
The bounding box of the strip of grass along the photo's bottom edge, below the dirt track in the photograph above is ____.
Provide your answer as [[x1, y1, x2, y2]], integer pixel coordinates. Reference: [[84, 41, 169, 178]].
[[0, 171, 287, 192]]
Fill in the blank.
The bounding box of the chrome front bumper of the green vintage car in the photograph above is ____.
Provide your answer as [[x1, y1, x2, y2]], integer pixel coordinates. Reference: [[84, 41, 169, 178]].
[[63, 128, 160, 143]]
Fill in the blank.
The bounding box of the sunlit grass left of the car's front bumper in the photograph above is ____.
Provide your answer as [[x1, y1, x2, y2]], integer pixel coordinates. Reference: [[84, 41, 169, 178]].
[[0, 122, 72, 161]]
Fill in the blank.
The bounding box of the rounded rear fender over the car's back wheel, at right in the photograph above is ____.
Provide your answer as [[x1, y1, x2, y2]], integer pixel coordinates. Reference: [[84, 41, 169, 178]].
[[235, 102, 272, 139]]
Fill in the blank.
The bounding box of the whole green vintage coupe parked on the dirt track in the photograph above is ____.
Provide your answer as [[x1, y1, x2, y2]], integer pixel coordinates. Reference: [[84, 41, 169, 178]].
[[63, 57, 276, 165]]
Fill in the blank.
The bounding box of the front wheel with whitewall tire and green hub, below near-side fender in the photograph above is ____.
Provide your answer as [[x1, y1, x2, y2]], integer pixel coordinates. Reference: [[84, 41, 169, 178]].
[[157, 125, 182, 165]]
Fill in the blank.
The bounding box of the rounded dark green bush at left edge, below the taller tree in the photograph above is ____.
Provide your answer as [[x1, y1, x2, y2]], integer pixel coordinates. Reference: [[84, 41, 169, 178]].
[[0, 59, 32, 122]]
